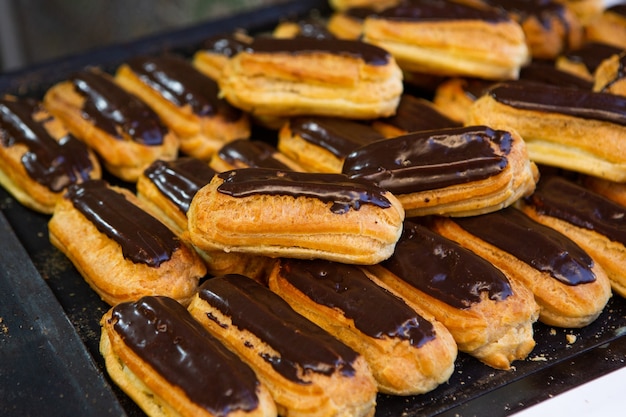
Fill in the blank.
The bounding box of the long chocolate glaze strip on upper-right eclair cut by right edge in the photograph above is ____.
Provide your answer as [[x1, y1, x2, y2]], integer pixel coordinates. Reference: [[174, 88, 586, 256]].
[[487, 81, 626, 125]]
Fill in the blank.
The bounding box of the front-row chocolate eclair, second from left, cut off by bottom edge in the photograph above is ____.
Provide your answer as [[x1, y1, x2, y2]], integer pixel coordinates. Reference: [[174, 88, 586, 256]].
[[189, 275, 376, 417]]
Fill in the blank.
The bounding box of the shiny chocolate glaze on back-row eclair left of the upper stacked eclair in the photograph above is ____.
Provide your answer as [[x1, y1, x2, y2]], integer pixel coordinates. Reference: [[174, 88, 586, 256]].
[[127, 56, 242, 122]]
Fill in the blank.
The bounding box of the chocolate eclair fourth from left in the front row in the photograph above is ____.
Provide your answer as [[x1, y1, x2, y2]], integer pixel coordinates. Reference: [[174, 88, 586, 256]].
[[368, 221, 539, 369]]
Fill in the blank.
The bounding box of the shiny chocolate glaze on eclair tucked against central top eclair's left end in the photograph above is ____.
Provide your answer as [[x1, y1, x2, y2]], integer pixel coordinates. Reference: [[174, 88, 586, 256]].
[[144, 157, 215, 213]]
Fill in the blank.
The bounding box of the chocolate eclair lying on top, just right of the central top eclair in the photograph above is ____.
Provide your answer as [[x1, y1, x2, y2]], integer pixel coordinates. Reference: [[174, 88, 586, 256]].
[[342, 126, 538, 217]]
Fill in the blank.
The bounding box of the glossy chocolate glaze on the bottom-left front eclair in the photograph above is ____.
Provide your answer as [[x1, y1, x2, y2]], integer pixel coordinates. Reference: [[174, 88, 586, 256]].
[[111, 297, 259, 416]]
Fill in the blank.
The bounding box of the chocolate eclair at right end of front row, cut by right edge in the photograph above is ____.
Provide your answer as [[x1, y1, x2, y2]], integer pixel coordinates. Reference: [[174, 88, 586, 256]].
[[522, 176, 626, 297]]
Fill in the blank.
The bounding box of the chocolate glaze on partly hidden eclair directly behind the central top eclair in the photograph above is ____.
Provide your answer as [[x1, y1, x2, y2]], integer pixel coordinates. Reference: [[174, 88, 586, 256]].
[[289, 116, 385, 158]]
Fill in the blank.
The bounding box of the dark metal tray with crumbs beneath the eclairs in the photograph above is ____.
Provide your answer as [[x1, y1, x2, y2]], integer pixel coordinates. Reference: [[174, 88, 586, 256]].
[[0, 1, 626, 417]]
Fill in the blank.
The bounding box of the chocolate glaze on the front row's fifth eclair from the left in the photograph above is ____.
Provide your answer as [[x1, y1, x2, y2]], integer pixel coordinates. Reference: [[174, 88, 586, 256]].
[[454, 207, 596, 285]]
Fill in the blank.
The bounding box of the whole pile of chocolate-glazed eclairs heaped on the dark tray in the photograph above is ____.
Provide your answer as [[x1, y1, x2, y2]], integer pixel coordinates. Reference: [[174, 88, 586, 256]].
[[0, 0, 626, 416]]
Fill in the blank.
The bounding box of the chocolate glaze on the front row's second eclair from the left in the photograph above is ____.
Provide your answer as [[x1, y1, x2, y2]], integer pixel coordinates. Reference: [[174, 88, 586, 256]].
[[198, 274, 358, 384]]
